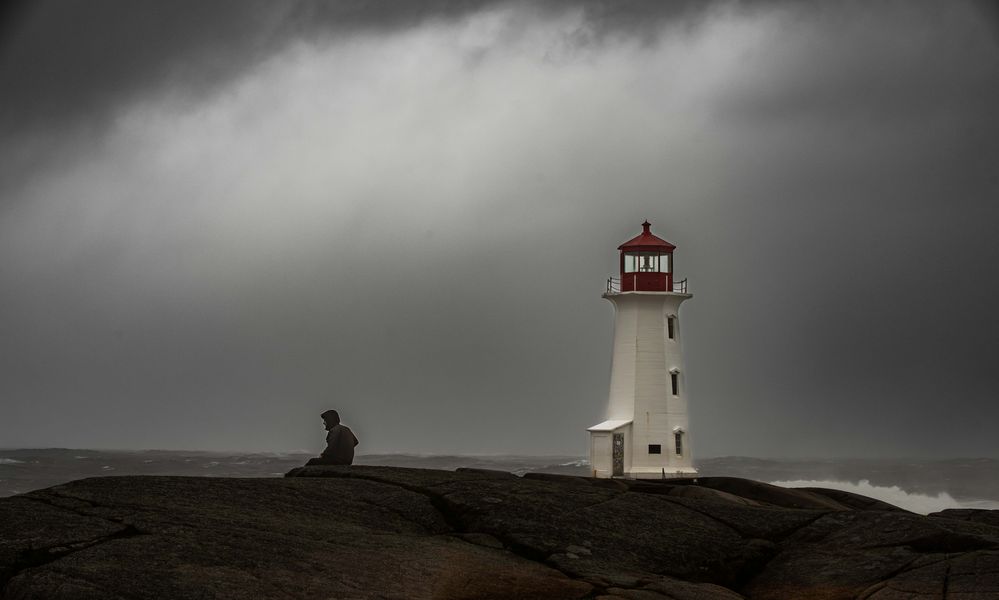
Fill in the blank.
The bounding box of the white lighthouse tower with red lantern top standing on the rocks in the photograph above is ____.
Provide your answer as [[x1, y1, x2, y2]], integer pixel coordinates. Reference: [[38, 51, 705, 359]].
[[588, 221, 697, 479]]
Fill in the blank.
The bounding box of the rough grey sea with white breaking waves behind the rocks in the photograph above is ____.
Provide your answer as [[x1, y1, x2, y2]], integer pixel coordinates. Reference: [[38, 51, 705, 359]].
[[0, 448, 999, 514]]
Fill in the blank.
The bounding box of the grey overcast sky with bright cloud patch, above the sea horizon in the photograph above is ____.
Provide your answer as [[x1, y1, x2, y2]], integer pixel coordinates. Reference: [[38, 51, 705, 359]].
[[0, 0, 999, 458]]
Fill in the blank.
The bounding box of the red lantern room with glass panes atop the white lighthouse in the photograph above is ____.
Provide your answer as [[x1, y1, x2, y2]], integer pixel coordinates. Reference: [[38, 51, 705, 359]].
[[618, 221, 687, 293]]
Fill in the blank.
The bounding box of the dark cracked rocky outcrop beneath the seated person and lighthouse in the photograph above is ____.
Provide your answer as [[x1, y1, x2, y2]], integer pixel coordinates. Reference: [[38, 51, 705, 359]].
[[0, 466, 999, 600]]
